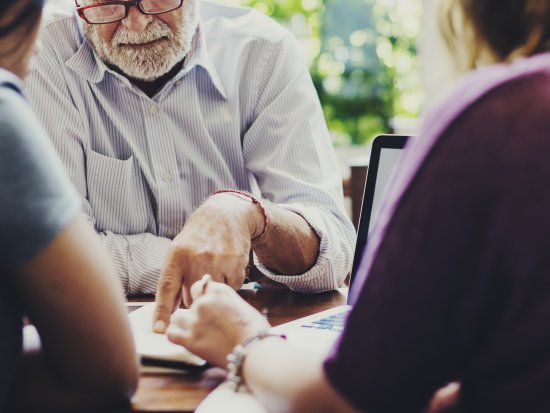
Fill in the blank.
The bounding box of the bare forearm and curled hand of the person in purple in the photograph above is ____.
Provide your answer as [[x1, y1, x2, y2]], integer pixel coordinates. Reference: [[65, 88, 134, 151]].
[[167, 282, 355, 413]]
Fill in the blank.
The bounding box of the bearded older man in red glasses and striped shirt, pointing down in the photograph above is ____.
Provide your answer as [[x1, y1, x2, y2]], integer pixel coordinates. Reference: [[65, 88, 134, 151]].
[[29, 0, 354, 306]]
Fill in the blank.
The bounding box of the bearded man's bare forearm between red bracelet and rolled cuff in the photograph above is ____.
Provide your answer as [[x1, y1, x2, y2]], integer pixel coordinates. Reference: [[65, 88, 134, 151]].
[[252, 201, 319, 275]]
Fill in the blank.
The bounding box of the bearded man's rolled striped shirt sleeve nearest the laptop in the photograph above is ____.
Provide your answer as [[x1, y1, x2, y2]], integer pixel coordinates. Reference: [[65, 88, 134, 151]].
[[243, 36, 355, 293]]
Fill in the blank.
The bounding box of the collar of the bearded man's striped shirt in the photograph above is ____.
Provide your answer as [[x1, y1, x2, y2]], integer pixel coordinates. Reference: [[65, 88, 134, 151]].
[[66, 15, 227, 99]]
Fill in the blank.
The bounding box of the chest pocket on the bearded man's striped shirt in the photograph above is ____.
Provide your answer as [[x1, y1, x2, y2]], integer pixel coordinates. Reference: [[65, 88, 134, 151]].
[[86, 149, 154, 235]]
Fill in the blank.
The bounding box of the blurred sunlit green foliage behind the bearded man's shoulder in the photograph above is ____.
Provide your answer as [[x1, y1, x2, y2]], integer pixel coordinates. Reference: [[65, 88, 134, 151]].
[[239, 0, 423, 145]]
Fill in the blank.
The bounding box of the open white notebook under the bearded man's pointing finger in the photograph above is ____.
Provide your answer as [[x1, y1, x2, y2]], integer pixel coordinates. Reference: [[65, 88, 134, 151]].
[[128, 303, 206, 370]]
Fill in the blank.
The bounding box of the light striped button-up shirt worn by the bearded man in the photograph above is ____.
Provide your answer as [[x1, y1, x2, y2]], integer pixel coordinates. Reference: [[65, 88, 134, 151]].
[[28, 2, 355, 294]]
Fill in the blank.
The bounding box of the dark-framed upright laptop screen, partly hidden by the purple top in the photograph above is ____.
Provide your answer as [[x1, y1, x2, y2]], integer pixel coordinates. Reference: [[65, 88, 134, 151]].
[[350, 135, 408, 287]]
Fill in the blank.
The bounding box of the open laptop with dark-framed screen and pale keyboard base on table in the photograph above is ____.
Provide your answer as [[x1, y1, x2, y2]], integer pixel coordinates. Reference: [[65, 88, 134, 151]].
[[273, 135, 408, 352]]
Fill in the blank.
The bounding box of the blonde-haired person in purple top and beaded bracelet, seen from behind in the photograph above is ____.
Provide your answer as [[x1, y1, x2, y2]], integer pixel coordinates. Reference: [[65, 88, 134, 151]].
[[168, 0, 550, 413]]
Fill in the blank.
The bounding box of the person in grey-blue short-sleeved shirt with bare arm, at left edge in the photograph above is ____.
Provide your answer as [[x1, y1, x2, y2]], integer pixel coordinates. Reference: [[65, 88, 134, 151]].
[[0, 0, 138, 412]]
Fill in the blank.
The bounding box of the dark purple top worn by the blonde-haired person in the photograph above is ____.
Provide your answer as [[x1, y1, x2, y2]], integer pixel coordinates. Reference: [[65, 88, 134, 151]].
[[325, 54, 550, 413]]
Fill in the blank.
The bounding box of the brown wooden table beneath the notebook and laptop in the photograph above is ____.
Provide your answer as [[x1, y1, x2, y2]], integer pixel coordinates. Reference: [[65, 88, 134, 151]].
[[130, 288, 346, 412]]
